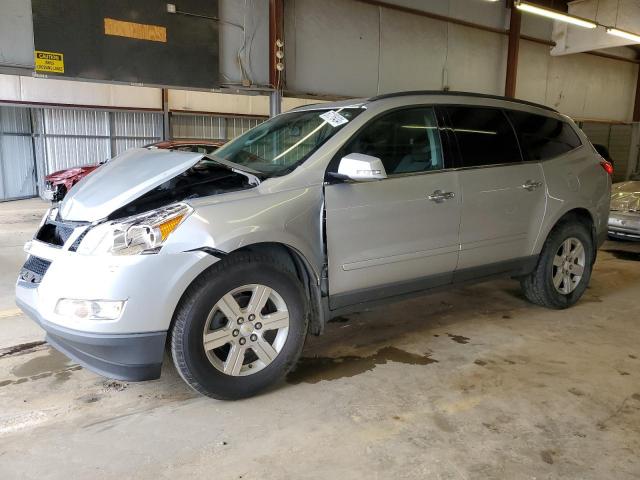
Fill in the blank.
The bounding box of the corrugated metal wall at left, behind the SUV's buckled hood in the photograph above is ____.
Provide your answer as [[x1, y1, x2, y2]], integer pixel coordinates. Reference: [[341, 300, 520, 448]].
[[0, 106, 265, 200]]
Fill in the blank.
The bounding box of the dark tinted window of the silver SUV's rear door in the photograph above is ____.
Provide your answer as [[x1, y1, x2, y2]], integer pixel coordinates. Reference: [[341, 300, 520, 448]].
[[446, 107, 522, 167]]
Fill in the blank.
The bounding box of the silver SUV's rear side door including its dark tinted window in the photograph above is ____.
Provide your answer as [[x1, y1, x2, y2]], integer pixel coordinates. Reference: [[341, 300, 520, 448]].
[[445, 106, 546, 272]]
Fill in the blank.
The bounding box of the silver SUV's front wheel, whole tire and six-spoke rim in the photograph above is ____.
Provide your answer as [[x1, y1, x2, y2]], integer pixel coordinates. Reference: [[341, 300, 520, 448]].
[[170, 253, 308, 400]]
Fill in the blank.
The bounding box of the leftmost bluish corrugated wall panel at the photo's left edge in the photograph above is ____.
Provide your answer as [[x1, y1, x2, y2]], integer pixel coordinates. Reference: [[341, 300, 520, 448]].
[[0, 107, 36, 200]]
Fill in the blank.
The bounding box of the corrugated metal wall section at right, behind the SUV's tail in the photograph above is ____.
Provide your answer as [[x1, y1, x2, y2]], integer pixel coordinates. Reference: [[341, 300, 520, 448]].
[[579, 122, 633, 182]]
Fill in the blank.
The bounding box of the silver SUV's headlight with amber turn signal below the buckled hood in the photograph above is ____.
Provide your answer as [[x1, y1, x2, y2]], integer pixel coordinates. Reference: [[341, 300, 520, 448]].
[[77, 203, 193, 255]]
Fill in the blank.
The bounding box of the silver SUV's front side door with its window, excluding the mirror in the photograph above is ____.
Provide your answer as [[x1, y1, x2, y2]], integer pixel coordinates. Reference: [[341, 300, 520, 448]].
[[325, 107, 461, 309]]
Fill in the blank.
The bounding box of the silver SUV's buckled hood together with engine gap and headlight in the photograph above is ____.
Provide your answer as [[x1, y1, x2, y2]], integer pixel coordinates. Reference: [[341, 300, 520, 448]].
[[35, 149, 260, 255]]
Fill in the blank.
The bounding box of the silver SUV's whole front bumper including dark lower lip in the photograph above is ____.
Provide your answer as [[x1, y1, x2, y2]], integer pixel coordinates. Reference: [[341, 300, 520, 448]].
[[16, 237, 217, 381]]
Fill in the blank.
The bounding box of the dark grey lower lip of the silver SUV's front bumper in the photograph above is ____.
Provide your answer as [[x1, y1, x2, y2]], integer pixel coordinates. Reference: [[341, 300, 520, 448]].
[[16, 299, 167, 382]]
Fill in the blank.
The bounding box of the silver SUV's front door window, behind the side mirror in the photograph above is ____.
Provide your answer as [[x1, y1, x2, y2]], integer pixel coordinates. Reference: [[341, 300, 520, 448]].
[[342, 108, 443, 175]]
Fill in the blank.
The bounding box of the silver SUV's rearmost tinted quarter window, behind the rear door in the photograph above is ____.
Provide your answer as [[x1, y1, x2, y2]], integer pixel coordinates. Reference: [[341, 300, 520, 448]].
[[507, 111, 582, 161]]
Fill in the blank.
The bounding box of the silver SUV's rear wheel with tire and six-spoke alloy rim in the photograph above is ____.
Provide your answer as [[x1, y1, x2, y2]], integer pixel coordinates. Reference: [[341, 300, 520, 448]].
[[520, 220, 595, 309]]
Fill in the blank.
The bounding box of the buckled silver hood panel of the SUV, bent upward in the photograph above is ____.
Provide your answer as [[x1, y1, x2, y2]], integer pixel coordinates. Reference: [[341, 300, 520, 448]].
[[59, 148, 203, 222]]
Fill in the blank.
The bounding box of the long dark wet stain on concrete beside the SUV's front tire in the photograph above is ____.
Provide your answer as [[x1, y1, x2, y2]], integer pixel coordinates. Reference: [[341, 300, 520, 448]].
[[287, 347, 438, 384]]
